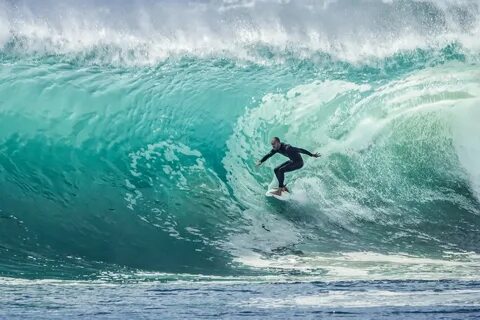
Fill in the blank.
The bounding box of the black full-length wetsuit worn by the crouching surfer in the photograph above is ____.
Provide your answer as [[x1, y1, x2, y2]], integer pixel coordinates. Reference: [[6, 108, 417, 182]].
[[260, 143, 314, 188]]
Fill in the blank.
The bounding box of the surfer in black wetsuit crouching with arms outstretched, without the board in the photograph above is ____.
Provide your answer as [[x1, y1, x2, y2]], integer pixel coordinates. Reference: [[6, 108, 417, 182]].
[[257, 137, 320, 195]]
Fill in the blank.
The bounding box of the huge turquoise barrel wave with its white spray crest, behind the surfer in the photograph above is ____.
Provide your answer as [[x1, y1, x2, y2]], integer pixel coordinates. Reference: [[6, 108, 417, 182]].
[[0, 0, 480, 279]]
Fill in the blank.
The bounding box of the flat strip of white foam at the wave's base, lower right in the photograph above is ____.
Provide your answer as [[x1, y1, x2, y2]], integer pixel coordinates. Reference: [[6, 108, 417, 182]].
[[236, 251, 480, 281]]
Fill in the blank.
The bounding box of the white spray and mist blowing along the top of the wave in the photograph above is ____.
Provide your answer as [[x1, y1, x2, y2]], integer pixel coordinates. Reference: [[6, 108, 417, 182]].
[[0, 0, 480, 64]]
